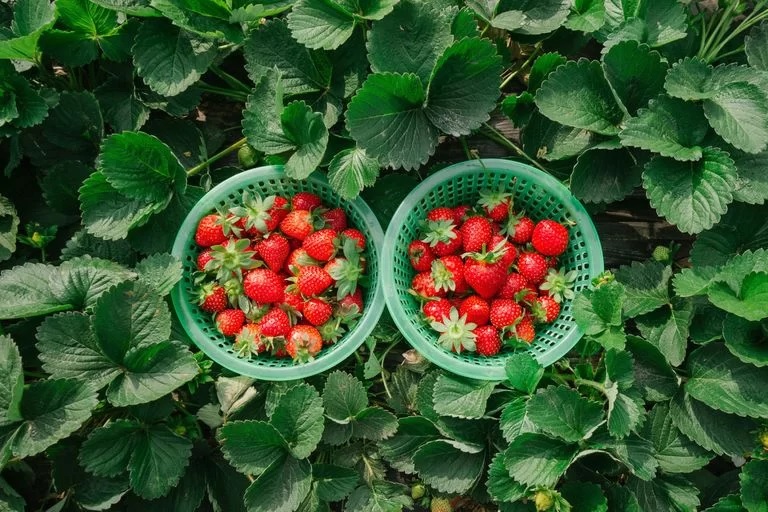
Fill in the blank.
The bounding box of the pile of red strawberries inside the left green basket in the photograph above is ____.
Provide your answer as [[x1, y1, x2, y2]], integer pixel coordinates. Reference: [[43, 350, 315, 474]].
[[195, 191, 366, 362]]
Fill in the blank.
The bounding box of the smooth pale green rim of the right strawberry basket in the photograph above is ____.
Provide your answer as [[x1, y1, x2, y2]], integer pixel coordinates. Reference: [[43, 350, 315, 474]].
[[381, 158, 604, 380]]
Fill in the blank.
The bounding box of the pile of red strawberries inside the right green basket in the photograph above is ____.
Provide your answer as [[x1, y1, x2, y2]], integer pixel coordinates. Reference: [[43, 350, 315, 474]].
[[408, 191, 576, 356]]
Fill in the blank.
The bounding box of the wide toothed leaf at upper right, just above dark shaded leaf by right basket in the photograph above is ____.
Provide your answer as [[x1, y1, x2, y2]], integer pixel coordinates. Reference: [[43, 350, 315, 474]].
[[619, 96, 709, 161]]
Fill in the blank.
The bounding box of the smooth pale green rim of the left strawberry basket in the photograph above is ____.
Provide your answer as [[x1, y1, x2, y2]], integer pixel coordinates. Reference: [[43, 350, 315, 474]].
[[171, 165, 384, 381]]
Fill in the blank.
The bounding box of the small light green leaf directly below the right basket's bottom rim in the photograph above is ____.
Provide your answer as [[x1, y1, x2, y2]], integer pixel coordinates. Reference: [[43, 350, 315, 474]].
[[433, 373, 496, 418]]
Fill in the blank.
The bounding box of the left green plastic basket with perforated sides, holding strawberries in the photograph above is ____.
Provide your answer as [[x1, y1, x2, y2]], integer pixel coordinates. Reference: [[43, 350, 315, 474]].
[[171, 165, 384, 381]]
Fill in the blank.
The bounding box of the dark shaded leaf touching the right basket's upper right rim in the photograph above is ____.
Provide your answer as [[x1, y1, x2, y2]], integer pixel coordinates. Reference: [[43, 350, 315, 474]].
[[571, 146, 643, 203]]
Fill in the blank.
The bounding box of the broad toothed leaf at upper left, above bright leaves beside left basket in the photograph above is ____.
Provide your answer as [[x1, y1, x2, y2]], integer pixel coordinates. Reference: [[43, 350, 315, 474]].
[[132, 20, 217, 96]]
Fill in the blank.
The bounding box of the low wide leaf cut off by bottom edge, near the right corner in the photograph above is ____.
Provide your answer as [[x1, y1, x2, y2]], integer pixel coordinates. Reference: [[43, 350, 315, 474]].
[[627, 475, 700, 512]]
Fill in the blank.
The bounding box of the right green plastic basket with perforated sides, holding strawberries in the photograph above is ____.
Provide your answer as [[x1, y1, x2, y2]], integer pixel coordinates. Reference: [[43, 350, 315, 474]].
[[382, 159, 603, 380]]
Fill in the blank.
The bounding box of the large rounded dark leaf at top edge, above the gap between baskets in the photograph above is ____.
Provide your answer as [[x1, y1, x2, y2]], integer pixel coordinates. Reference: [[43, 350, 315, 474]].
[[366, 0, 454, 85]]
